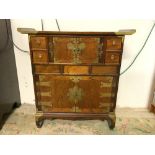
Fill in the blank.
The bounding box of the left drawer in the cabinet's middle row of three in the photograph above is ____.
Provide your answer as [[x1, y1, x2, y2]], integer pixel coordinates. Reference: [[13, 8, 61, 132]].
[[35, 65, 60, 74]]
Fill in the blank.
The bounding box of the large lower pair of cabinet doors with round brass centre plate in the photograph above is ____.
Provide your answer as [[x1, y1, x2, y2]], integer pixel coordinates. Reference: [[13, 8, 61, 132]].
[[36, 75, 116, 113]]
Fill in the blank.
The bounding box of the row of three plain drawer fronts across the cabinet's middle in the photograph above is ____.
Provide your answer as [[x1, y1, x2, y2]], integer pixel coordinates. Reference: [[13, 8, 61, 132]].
[[34, 64, 119, 75]]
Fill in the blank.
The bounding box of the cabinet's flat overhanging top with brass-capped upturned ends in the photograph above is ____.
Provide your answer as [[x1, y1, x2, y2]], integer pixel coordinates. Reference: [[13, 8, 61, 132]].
[[17, 28, 136, 36]]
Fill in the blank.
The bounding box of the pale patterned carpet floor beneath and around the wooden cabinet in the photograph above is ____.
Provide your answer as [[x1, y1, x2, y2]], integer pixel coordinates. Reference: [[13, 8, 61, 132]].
[[0, 104, 155, 135]]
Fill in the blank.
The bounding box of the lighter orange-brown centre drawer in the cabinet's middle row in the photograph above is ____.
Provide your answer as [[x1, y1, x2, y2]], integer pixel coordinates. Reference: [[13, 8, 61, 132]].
[[64, 66, 89, 74]]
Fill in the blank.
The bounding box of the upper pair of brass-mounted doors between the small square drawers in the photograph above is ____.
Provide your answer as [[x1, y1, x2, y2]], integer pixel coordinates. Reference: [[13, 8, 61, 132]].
[[49, 37, 102, 63]]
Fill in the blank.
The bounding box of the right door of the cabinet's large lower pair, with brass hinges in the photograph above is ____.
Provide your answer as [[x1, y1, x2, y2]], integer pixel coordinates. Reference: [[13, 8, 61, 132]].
[[76, 76, 116, 113]]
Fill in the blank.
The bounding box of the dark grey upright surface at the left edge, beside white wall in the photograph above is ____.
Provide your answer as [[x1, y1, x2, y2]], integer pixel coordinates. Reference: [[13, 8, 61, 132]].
[[0, 19, 20, 104]]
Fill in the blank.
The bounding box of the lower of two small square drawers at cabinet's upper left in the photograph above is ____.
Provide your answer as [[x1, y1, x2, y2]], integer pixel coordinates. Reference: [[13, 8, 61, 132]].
[[32, 51, 48, 63]]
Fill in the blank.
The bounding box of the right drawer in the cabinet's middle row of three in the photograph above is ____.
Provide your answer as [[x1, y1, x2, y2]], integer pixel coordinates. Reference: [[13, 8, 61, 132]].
[[92, 66, 118, 75]]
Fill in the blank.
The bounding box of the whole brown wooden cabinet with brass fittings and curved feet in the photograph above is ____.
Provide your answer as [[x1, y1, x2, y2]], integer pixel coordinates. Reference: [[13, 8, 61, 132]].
[[18, 29, 135, 129]]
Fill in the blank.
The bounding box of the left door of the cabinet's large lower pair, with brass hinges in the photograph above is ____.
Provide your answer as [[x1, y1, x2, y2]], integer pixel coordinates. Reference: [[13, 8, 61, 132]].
[[36, 75, 75, 112]]
